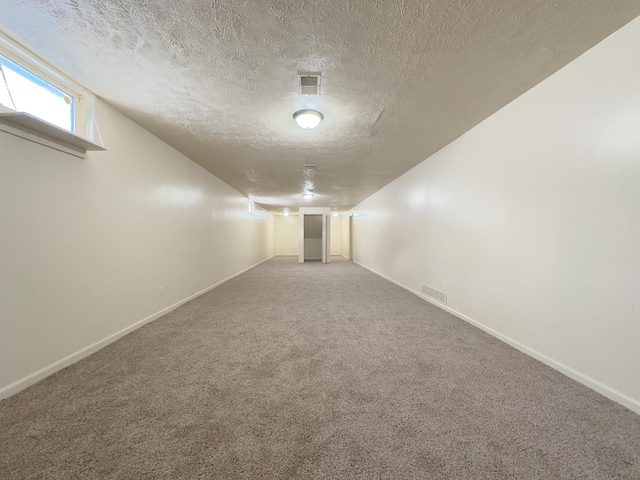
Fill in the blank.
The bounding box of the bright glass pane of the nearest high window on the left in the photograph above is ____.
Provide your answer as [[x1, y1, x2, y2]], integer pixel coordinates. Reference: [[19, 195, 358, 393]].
[[0, 55, 75, 132]]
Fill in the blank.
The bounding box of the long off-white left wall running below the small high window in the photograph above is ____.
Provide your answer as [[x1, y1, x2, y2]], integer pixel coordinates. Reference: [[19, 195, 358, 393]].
[[0, 97, 273, 398]]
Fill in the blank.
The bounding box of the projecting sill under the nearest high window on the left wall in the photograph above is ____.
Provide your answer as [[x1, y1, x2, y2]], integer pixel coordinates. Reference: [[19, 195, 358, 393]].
[[0, 112, 106, 158]]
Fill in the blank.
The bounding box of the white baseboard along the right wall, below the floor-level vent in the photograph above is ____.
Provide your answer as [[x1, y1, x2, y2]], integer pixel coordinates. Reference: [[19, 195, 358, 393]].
[[354, 260, 640, 415]]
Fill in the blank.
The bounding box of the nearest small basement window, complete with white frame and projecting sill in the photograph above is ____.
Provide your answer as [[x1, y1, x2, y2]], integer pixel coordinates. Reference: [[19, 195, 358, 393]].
[[0, 34, 104, 158]]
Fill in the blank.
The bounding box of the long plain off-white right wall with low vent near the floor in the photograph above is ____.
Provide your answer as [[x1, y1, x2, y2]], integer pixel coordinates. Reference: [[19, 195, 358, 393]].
[[354, 18, 640, 413]]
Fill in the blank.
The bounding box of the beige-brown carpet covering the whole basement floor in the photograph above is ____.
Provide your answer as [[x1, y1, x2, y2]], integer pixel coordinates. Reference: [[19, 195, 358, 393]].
[[0, 258, 640, 479]]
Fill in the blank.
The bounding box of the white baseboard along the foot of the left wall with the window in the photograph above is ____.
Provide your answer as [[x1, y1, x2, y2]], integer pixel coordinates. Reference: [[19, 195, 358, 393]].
[[0, 255, 274, 400]]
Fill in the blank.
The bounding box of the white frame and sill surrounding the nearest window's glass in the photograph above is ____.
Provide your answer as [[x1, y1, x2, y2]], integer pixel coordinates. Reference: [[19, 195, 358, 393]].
[[0, 32, 104, 158]]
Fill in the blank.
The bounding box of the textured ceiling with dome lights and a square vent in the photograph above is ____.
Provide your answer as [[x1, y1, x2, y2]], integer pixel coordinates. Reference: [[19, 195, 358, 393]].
[[0, 0, 640, 210]]
